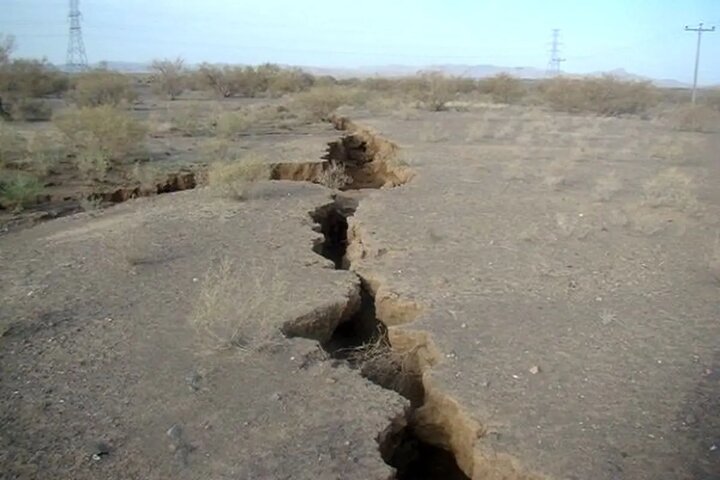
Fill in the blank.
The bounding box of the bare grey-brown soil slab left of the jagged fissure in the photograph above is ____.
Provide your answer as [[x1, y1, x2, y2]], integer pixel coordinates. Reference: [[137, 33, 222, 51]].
[[0, 182, 407, 479]]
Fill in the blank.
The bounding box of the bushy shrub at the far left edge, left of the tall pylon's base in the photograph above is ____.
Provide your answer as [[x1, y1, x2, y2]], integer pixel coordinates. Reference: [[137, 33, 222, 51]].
[[0, 59, 68, 98]]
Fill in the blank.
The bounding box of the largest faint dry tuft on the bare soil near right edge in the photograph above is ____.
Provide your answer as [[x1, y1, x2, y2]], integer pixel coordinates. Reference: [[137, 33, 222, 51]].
[[643, 167, 697, 210]]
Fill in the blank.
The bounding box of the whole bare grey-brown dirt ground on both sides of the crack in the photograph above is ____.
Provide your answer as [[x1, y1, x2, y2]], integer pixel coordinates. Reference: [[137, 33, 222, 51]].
[[0, 91, 720, 479]]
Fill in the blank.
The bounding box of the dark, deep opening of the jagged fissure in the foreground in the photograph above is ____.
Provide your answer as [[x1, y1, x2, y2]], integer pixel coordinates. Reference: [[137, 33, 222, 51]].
[[311, 195, 469, 480]]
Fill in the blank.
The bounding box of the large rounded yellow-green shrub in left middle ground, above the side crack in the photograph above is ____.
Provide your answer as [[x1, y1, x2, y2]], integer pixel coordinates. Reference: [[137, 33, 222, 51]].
[[53, 105, 146, 161]]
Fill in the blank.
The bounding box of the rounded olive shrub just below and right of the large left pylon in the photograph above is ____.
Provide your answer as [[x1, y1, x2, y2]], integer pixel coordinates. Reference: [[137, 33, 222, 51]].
[[70, 70, 137, 107]]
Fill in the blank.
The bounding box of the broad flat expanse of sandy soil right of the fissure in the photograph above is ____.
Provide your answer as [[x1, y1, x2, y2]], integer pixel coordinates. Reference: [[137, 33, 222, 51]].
[[348, 108, 720, 479]]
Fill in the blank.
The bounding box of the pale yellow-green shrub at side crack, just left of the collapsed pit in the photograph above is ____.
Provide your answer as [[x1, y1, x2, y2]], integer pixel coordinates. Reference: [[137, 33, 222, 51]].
[[208, 156, 272, 200]]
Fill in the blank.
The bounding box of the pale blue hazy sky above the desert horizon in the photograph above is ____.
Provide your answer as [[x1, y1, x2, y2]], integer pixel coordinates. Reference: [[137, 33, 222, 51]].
[[0, 0, 720, 84]]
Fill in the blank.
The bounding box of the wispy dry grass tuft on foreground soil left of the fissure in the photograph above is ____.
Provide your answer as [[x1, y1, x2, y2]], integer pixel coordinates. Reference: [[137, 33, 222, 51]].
[[189, 258, 287, 353]]
